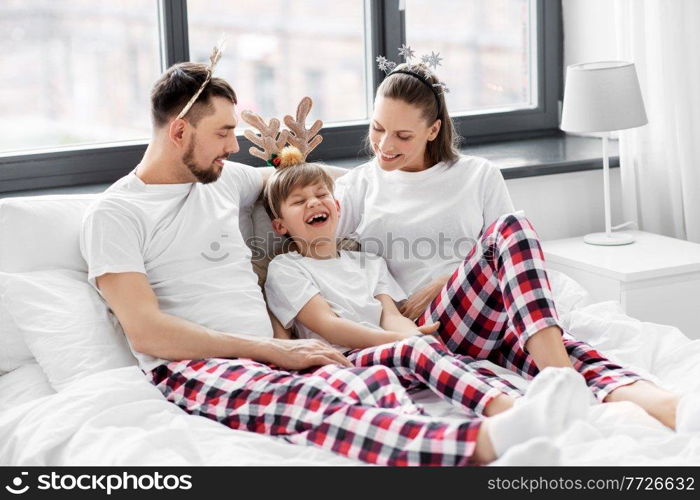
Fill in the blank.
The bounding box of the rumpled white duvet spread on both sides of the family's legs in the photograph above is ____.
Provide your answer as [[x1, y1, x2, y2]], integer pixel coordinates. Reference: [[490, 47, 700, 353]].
[[0, 290, 700, 465]]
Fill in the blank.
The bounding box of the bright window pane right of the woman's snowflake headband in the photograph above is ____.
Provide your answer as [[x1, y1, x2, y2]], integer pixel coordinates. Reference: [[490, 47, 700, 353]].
[[406, 0, 537, 114]]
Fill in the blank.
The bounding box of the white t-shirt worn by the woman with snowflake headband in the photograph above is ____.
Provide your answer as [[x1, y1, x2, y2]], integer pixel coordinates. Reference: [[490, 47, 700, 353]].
[[335, 156, 514, 295]]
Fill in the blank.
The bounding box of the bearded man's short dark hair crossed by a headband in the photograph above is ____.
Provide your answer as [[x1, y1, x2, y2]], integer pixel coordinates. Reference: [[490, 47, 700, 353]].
[[151, 62, 238, 128]]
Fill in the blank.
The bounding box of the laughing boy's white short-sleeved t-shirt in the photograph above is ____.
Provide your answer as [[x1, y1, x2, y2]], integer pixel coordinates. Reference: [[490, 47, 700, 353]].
[[265, 250, 406, 352]]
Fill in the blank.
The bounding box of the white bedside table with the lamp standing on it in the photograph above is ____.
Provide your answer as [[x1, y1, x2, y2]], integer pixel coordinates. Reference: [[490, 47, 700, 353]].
[[542, 231, 700, 339]]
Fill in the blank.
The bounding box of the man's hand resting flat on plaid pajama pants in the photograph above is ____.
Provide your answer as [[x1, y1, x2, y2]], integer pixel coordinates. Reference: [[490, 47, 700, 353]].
[[257, 339, 352, 370]]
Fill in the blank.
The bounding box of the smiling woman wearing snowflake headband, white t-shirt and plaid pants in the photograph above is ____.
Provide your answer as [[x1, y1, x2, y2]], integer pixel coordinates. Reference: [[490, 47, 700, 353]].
[[336, 64, 700, 431]]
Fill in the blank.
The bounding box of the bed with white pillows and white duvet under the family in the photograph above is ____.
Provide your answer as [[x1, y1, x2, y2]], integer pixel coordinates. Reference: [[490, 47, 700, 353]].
[[0, 195, 700, 466]]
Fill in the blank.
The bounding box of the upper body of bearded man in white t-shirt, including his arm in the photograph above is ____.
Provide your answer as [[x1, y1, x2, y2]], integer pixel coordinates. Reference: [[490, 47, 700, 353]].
[[81, 63, 346, 369]]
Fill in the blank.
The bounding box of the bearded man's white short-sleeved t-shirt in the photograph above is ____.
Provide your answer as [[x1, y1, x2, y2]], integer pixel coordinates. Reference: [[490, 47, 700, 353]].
[[80, 162, 272, 370]]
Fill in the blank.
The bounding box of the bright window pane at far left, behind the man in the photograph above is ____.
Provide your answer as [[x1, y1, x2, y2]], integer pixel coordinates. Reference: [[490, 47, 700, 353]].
[[0, 0, 160, 151]]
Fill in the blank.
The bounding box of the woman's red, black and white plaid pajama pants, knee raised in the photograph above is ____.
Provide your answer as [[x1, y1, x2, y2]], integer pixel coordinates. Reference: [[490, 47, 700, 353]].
[[417, 214, 642, 401]]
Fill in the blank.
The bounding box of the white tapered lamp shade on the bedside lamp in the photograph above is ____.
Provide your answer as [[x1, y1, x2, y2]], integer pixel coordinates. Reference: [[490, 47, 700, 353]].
[[561, 61, 648, 132]]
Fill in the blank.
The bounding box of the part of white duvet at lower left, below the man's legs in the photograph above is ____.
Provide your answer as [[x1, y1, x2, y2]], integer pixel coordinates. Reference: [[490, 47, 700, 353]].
[[0, 367, 357, 465]]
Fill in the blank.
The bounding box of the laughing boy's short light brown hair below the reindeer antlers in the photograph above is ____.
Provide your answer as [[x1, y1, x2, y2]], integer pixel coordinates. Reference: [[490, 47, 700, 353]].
[[263, 163, 335, 219]]
